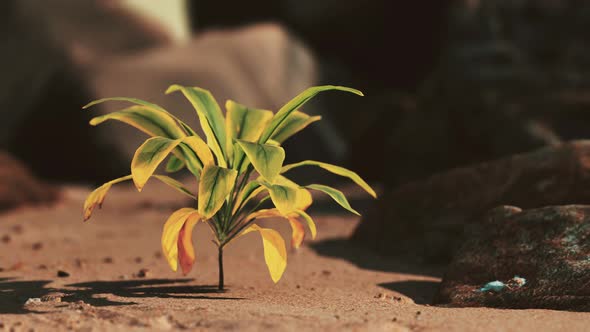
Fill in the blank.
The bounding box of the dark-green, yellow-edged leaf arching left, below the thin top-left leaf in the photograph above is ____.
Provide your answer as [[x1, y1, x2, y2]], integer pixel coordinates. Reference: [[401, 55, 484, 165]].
[[90, 105, 186, 139]]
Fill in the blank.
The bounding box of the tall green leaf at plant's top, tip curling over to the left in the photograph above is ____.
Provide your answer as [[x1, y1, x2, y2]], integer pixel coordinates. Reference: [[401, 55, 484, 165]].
[[166, 85, 229, 167]]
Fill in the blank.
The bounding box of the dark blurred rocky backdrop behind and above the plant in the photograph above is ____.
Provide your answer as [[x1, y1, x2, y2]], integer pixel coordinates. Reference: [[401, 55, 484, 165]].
[[0, 0, 590, 192]]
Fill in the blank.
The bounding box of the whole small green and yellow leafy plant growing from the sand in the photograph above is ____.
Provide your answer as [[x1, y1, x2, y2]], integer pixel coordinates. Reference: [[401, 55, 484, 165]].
[[84, 85, 376, 290]]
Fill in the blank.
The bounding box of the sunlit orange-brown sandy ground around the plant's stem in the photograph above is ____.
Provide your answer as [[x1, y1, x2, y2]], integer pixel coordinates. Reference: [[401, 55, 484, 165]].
[[0, 185, 590, 331]]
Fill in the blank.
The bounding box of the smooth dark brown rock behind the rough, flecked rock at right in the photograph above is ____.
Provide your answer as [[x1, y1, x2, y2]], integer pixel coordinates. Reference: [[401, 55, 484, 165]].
[[352, 141, 590, 262]]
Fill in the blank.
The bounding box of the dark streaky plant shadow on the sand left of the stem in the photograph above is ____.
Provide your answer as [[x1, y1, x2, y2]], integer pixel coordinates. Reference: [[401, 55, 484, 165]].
[[0, 278, 240, 314]]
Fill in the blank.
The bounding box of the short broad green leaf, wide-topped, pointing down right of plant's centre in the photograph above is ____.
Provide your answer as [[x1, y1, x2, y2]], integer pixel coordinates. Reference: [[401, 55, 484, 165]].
[[237, 141, 285, 183]]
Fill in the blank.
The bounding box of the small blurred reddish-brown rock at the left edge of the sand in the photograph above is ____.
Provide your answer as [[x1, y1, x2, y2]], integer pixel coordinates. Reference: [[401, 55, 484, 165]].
[[0, 151, 59, 211]]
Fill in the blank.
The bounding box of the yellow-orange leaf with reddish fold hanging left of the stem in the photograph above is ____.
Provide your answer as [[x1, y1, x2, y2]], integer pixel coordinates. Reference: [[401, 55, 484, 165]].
[[162, 208, 202, 272]]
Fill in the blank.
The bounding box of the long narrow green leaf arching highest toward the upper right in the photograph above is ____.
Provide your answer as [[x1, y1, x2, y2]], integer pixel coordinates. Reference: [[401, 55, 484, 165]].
[[258, 85, 363, 143]]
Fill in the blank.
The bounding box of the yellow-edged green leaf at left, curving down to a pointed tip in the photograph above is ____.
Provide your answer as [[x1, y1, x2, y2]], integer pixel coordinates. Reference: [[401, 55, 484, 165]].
[[131, 137, 182, 191]]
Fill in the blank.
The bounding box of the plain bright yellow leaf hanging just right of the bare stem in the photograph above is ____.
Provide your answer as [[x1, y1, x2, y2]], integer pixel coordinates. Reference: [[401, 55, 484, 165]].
[[242, 224, 287, 283]]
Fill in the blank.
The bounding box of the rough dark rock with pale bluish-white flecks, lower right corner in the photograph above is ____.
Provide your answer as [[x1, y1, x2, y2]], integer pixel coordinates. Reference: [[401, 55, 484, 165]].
[[435, 205, 590, 311]]
